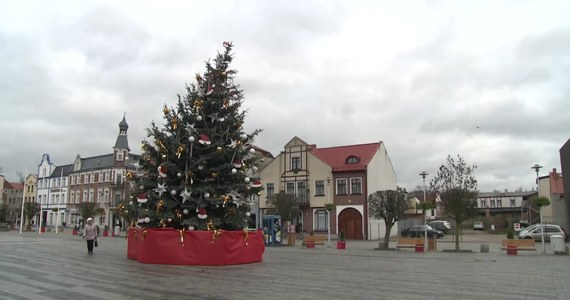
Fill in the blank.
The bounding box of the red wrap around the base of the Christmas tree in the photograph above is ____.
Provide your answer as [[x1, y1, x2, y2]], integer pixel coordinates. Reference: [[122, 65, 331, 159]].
[[127, 228, 265, 266]]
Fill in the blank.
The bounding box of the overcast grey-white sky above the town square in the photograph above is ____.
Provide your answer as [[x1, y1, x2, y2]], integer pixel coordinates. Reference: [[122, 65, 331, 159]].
[[0, 0, 570, 191]]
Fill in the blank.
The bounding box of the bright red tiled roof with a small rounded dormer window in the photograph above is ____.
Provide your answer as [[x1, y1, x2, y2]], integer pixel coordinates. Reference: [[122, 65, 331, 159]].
[[310, 142, 382, 172]]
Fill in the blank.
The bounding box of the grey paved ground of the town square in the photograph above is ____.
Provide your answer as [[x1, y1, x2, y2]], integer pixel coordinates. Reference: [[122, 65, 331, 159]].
[[0, 231, 570, 299]]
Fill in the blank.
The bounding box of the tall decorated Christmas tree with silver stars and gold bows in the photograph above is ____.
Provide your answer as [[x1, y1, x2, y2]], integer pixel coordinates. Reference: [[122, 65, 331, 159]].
[[132, 42, 261, 230]]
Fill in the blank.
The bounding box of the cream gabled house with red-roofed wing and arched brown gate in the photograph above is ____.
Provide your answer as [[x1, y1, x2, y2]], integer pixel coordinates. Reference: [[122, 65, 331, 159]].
[[259, 137, 397, 239]]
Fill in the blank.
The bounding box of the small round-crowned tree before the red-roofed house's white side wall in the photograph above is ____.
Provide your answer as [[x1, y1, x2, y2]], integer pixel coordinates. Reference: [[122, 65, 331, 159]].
[[368, 190, 409, 249]]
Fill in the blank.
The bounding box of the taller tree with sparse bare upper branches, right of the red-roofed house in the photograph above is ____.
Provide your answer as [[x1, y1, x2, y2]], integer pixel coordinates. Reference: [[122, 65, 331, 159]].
[[430, 155, 477, 251]]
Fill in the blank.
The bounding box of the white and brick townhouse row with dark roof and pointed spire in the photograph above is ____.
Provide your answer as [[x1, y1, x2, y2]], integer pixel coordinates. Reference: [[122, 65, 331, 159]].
[[37, 116, 140, 228]]
